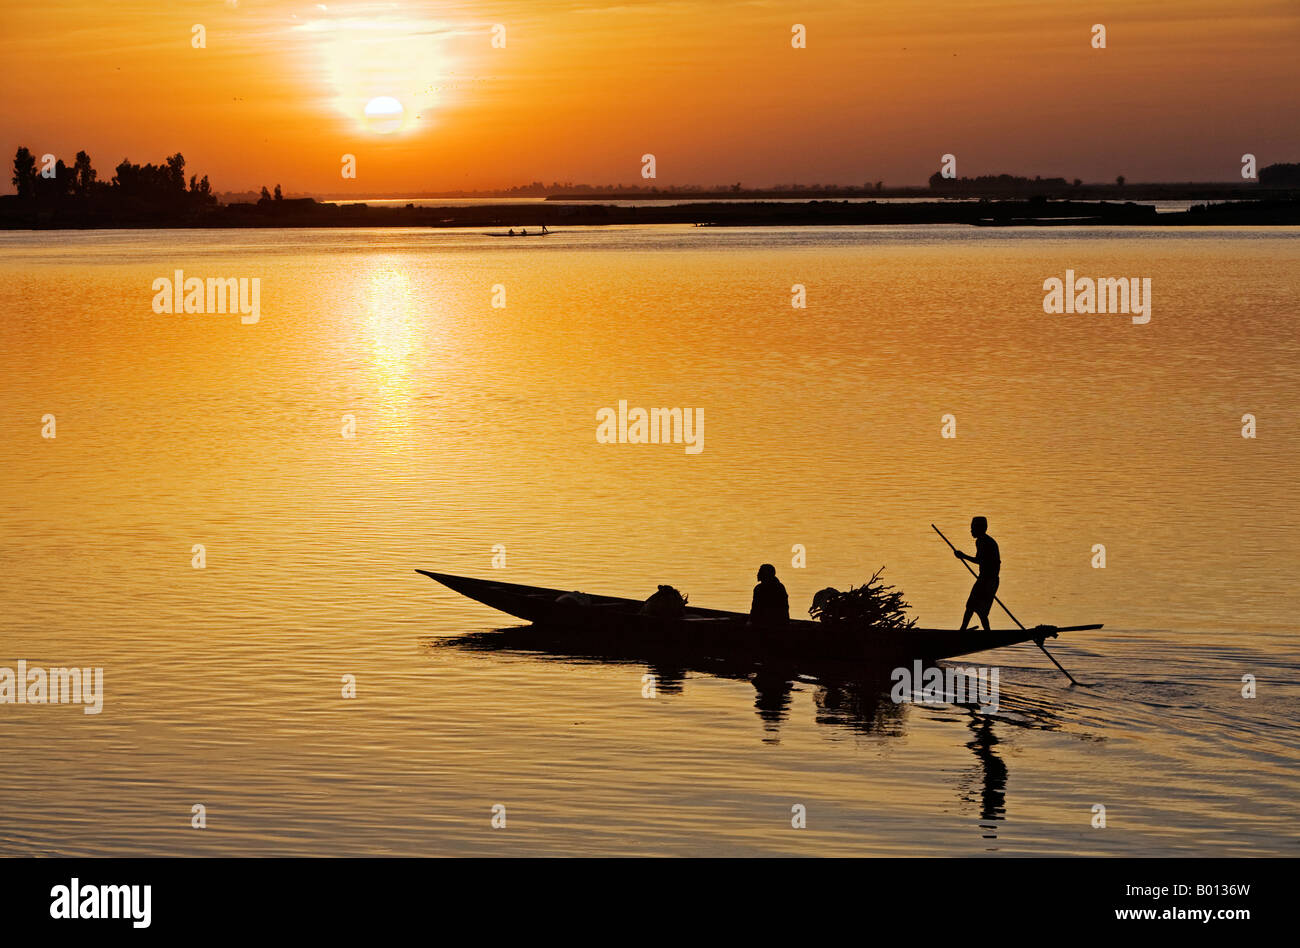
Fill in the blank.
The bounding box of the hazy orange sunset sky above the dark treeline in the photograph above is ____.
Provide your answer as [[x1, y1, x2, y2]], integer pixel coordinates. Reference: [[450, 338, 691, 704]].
[[0, 0, 1300, 195]]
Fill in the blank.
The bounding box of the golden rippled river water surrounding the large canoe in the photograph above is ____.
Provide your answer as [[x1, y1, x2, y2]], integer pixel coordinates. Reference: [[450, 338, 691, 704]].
[[0, 228, 1300, 856]]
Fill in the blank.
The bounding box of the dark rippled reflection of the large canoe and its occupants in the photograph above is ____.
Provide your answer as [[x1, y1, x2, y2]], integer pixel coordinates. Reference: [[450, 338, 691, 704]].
[[428, 625, 1058, 849]]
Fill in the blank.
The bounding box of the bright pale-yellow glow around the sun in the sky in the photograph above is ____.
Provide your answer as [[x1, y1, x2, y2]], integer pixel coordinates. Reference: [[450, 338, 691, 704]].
[[295, 8, 462, 135]]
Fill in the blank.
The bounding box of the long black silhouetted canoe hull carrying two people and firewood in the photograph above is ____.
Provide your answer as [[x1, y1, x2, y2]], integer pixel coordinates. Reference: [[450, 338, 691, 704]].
[[416, 570, 1101, 663]]
